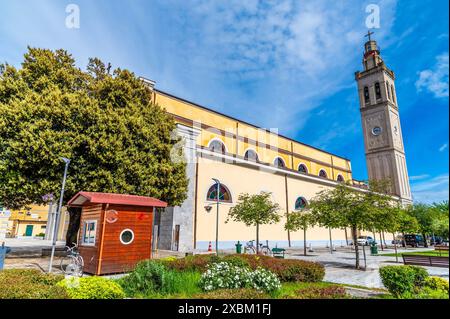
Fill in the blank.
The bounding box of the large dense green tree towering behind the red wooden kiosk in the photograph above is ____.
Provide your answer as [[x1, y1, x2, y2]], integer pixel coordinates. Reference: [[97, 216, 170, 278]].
[[0, 48, 187, 243]]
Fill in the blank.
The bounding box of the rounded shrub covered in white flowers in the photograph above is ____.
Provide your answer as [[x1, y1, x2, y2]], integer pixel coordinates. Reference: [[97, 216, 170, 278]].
[[199, 261, 281, 292]]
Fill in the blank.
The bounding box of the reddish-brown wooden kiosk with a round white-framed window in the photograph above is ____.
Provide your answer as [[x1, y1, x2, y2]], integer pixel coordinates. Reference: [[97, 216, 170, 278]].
[[68, 192, 167, 275]]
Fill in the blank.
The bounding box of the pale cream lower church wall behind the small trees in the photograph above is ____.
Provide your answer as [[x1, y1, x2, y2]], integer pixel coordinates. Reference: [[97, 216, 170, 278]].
[[196, 158, 345, 242]]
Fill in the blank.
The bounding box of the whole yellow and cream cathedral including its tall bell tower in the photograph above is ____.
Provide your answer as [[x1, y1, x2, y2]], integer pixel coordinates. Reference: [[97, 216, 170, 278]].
[[143, 37, 411, 251]]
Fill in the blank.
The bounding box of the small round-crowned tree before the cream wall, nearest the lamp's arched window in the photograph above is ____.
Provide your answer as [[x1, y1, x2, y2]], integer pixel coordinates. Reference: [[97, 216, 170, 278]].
[[225, 192, 280, 253]]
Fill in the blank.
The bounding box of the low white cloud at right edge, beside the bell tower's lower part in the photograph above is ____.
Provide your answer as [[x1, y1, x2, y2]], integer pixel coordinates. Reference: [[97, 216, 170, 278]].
[[411, 174, 449, 204]]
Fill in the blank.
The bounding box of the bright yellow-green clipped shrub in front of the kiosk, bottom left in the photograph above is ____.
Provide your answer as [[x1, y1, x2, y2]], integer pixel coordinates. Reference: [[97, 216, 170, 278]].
[[58, 277, 125, 299]]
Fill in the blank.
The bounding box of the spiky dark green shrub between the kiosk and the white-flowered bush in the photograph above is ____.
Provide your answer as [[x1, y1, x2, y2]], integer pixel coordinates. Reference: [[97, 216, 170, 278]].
[[118, 260, 204, 298]]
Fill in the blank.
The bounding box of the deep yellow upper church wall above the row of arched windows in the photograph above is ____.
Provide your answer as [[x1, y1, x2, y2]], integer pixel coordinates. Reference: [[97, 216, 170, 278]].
[[155, 91, 351, 180]]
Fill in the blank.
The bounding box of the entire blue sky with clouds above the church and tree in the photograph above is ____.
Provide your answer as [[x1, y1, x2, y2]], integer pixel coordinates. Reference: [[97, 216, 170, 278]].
[[0, 0, 449, 202]]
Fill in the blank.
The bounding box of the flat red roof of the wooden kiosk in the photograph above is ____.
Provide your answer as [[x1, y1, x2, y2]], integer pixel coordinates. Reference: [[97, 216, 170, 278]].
[[67, 192, 167, 207]]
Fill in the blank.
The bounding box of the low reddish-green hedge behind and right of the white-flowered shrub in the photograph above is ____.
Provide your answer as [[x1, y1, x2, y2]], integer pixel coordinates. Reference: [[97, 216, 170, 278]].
[[225, 254, 325, 282]]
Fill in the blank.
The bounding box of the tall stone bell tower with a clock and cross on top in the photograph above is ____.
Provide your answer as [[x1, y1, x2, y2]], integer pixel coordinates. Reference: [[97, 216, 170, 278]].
[[355, 32, 412, 204]]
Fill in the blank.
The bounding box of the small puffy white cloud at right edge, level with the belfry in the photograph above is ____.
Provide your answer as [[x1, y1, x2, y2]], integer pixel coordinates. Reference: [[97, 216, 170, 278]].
[[416, 52, 449, 98]]
